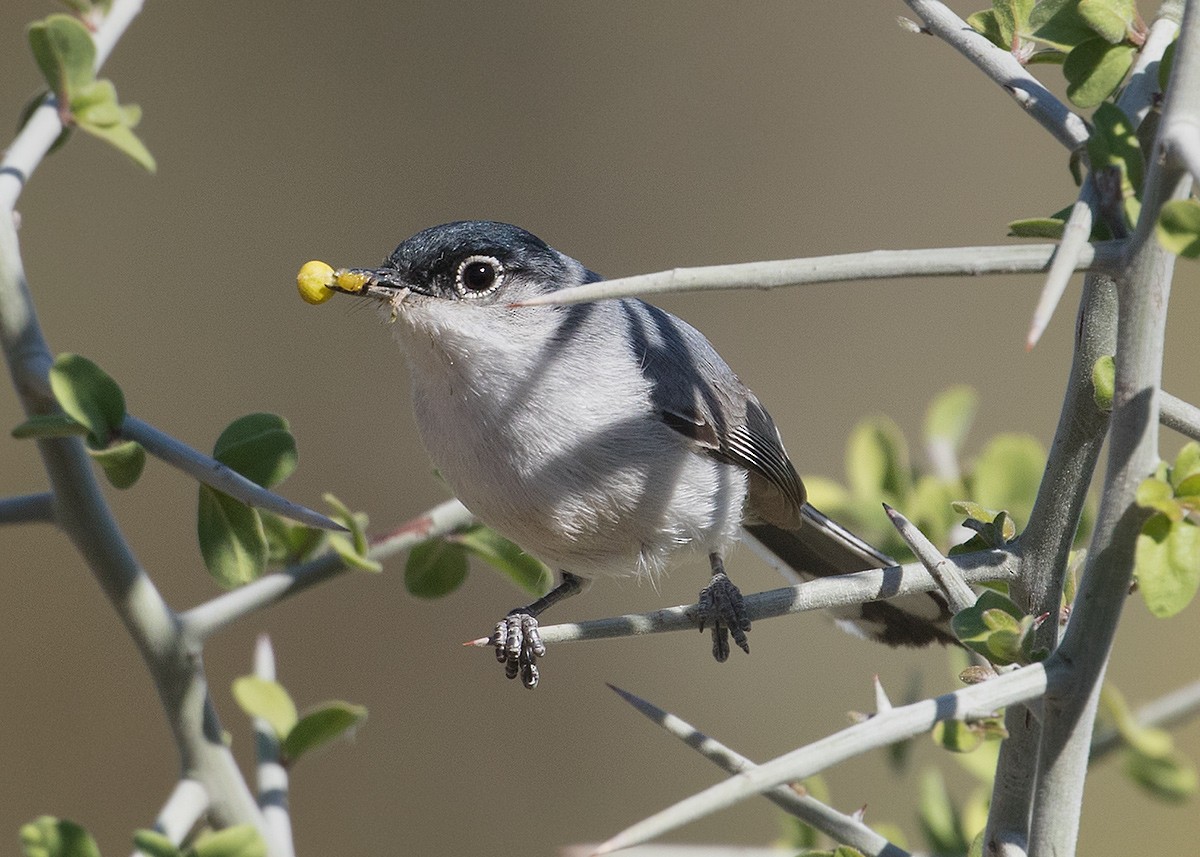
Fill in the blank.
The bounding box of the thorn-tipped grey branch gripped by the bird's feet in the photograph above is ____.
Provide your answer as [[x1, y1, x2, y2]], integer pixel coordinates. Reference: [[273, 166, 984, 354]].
[[468, 551, 1018, 648]]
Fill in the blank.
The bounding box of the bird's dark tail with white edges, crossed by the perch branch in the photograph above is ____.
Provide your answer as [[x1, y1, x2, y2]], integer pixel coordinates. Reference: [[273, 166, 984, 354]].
[[745, 503, 958, 646]]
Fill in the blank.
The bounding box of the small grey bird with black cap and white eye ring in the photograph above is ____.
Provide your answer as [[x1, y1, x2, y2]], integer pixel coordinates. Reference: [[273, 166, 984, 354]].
[[338, 221, 954, 688]]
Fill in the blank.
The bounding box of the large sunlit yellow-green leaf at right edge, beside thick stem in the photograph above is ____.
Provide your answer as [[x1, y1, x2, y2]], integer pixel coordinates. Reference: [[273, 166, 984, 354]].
[[1134, 513, 1200, 618]]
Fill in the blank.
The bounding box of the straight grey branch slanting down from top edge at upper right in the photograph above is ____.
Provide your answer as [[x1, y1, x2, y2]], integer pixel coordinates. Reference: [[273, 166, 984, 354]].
[[905, 0, 1088, 150]]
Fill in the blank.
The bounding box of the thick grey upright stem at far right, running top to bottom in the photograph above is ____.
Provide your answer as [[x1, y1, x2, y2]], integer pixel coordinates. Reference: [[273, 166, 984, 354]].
[[1030, 4, 1200, 855]]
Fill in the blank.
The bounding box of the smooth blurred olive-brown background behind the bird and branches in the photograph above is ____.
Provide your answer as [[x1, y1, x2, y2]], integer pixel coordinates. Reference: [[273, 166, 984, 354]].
[[0, 0, 1200, 855]]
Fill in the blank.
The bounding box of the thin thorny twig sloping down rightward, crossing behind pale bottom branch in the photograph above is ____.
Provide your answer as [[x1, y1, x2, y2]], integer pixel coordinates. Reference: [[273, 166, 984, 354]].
[[608, 684, 910, 857]]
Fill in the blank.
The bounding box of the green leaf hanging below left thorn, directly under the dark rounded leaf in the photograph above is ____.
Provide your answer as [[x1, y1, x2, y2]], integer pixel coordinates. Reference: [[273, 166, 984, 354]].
[[197, 485, 266, 589]]
